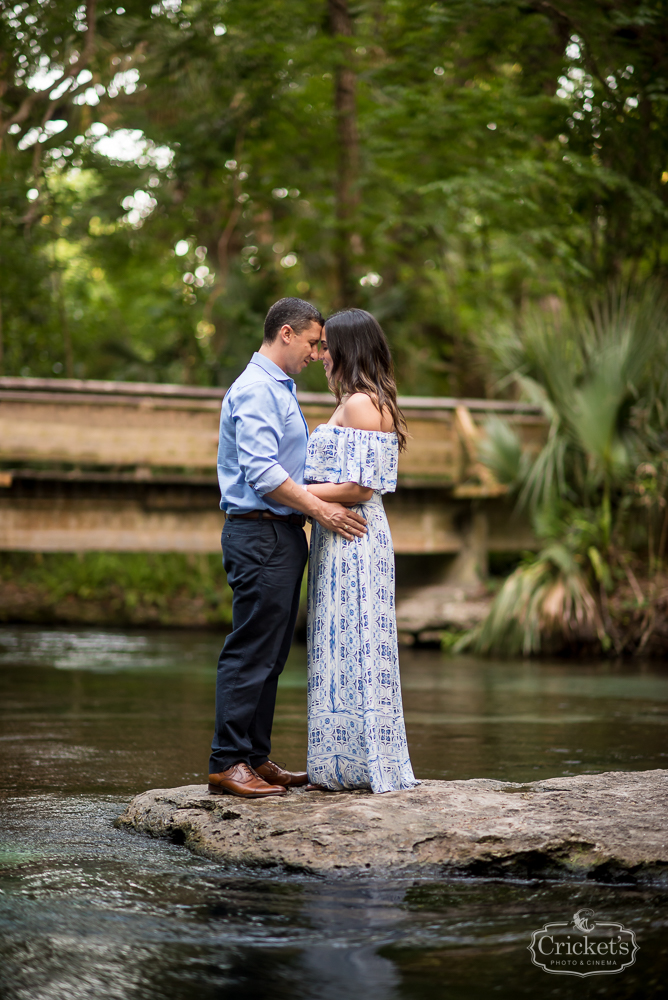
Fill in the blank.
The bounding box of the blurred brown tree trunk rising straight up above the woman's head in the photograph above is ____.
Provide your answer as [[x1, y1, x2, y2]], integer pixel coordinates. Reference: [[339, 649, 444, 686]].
[[327, 0, 359, 307]]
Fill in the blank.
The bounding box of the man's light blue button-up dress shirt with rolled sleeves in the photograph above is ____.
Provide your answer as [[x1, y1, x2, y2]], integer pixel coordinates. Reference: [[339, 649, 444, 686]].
[[218, 352, 308, 514]]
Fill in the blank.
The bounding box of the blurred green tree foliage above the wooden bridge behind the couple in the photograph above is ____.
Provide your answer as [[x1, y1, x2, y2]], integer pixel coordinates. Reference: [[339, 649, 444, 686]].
[[0, 0, 668, 394]]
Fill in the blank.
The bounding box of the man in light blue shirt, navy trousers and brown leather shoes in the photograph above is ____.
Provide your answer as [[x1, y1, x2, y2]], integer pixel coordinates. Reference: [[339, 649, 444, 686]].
[[209, 298, 366, 798]]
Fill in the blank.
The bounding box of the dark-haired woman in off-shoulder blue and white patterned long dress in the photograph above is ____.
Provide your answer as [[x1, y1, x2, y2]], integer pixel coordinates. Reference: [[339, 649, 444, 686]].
[[305, 309, 419, 792]]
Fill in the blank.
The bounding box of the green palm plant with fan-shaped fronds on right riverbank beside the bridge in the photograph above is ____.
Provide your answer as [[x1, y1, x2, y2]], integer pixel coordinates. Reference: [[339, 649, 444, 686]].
[[465, 286, 668, 654]]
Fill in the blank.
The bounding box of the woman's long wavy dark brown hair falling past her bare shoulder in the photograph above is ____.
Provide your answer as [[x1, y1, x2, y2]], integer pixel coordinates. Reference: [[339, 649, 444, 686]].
[[325, 309, 406, 451]]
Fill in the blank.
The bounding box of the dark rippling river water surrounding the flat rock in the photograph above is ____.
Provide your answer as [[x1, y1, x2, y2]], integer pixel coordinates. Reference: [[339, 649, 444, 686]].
[[0, 627, 668, 1000]]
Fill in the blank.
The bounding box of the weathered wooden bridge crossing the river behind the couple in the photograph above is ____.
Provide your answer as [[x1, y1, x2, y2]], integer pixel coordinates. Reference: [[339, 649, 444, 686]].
[[0, 377, 545, 582]]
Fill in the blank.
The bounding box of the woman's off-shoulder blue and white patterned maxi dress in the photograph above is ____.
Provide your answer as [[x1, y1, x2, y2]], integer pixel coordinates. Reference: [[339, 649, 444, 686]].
[[305, 424, 419, 792]]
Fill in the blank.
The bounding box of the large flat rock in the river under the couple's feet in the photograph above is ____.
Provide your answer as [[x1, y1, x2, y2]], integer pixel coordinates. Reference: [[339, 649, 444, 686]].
[[117, 770, 668, 881]]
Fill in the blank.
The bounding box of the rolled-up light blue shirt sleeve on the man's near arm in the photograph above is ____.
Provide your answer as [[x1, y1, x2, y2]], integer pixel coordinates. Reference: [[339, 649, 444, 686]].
[[231, 382, 290, 496]]
